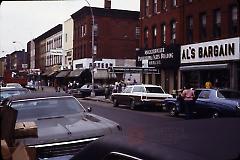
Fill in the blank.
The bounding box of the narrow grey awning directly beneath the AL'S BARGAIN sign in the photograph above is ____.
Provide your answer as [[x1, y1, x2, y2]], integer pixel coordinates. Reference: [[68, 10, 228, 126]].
[[179, 64, 228, 71]]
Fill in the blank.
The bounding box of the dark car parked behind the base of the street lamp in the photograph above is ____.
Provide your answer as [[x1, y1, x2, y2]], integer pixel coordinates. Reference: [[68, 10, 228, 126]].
[[68, 84, 105, 97]]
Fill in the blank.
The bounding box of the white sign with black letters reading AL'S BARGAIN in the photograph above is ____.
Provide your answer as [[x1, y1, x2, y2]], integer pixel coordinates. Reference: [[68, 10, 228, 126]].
[[181, 37, 240, 64]]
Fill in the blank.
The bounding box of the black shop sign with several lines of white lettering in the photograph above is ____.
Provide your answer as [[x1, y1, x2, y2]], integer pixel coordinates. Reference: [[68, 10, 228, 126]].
[[137, 45, 180, 68]]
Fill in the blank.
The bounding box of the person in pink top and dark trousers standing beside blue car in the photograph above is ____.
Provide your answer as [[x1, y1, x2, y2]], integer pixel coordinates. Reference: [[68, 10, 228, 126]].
[[181, 87, 195, 119]]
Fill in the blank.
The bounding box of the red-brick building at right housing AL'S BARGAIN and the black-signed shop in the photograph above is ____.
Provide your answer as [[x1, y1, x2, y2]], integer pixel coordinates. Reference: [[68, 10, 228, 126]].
[[137, 0, 240, 93]]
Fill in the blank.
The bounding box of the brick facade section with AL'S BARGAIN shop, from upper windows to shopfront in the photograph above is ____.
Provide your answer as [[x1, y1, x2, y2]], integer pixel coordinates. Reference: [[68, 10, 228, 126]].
[[180, 0, 240, 90]]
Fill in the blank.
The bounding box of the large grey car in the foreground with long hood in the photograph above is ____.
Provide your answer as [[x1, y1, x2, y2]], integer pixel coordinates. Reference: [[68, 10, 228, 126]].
[[4, 92, 121, 159]]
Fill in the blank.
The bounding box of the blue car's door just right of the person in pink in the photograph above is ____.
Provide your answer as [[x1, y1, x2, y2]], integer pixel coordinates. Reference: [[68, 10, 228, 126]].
[[194, 90, 211, 115]]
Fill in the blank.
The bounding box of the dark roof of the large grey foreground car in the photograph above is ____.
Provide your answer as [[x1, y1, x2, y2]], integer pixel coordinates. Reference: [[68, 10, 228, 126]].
[[7, 92, 73, 101]]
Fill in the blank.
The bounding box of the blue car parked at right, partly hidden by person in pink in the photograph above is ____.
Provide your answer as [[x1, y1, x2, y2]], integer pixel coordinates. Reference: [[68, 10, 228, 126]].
[[165, 89, 240, 118]]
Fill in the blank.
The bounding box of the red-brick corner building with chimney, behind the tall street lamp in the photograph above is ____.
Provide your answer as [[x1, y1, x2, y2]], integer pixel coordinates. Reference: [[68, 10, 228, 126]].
[[72, 0, 140, 79]]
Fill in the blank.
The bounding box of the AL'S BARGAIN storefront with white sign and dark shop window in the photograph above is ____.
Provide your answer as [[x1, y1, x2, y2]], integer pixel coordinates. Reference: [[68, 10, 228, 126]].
[[180, 37, 240, 90]]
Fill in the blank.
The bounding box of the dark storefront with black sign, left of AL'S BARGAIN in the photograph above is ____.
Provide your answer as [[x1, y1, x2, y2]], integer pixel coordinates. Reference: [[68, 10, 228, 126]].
[[137, 45, 180, 93]]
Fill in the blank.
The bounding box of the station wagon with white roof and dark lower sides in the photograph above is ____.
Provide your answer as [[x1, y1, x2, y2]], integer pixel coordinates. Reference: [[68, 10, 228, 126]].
[[111, 84, 172, 109]]
